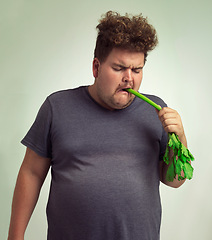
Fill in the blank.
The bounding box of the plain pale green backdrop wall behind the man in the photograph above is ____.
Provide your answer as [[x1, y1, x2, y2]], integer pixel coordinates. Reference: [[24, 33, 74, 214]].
[[0, 0, 212, 240]]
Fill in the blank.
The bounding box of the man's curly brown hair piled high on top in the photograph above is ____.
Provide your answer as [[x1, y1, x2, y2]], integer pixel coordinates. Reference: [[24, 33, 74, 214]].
[[94, 11, 158, 62]]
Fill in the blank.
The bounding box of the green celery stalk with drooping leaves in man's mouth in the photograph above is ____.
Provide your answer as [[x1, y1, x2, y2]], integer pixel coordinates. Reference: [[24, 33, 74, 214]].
[[125, 88, 194, 182]]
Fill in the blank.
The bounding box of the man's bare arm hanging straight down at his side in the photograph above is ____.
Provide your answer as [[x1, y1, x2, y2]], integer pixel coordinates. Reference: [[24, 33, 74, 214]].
[[8, 148, 50, 240]]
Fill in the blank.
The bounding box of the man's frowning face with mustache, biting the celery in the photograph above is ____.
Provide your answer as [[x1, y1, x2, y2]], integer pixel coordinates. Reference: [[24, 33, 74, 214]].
[[89, 48, 144, 110]]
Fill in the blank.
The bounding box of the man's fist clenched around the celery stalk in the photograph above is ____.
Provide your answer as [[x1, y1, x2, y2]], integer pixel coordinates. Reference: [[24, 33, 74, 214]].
[[158, 107, 187, 147]]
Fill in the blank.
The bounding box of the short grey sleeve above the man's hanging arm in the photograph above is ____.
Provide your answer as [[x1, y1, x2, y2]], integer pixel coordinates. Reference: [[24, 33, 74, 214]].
[[21, 98, 52, 158]]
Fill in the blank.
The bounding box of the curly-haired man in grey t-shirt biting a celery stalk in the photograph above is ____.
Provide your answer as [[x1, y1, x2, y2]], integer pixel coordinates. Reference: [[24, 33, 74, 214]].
[[8, 12, 186, 240]]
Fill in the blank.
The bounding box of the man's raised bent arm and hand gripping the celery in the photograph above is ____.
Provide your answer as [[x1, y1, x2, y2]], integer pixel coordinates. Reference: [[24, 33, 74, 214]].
[[158, 107, 187, 188]]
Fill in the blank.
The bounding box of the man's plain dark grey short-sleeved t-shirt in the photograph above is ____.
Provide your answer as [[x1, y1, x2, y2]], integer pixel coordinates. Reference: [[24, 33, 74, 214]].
[[22, 86, 167, 240]]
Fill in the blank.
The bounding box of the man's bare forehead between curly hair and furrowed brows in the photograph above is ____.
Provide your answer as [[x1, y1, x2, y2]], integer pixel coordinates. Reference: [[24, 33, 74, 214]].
[[106, 48, 144, 67]]
